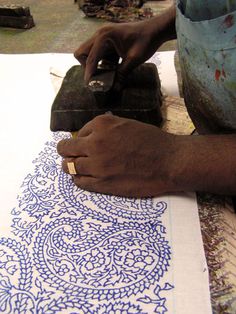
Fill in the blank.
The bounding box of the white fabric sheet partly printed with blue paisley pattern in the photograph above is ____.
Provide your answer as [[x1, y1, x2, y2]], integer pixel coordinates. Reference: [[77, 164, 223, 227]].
[[0, 52, 211, 314]]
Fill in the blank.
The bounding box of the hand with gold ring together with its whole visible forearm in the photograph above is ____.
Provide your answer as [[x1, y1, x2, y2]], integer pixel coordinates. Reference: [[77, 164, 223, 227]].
[[58, 115, 236, 197]]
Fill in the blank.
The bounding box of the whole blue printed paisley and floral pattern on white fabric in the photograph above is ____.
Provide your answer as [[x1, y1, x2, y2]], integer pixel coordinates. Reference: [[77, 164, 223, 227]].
[[0, 133, 174, 314]]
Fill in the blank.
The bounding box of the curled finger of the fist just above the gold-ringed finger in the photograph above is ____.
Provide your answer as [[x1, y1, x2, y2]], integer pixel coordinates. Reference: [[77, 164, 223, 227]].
[[57, 138, 87, 157]]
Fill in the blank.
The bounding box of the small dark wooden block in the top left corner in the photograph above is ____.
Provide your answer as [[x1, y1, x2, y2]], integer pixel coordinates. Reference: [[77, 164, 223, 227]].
[[0, 5, 35, 29]]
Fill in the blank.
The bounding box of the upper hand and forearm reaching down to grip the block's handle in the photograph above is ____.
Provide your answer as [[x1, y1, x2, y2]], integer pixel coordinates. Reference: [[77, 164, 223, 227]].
[[74, 6, 176, 82]]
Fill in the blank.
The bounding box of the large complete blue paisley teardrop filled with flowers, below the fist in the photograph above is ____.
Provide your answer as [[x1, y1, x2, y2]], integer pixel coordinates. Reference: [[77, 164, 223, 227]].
[[34, 216, 170, 299]]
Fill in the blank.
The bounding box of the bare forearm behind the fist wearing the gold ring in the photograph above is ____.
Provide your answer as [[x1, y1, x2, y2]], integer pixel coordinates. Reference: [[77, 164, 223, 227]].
[[171, 134, 236, 195]]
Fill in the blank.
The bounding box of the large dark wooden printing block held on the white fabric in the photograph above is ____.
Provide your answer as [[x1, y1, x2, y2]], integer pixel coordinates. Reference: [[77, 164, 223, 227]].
[[50, 63, 162, 132]]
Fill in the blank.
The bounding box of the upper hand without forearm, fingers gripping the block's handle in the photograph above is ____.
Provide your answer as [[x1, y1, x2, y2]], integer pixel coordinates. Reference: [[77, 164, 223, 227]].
[[74, 22, 158, 83]]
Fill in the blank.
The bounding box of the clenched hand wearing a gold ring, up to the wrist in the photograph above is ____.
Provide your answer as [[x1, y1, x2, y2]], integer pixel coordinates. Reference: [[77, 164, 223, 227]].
[[57, 114, 179, 197]]
